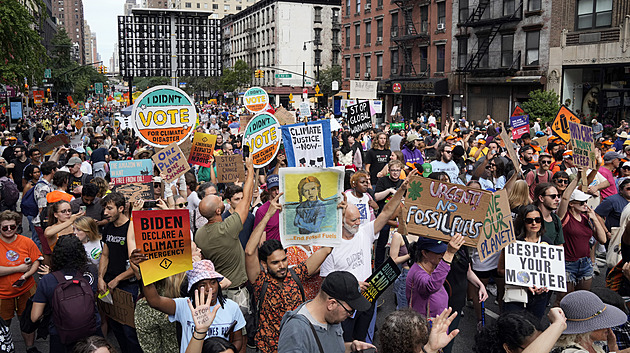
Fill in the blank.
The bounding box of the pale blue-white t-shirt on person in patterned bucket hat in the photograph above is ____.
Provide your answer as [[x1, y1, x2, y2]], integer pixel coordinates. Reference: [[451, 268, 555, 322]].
[[168, 298, 245, 353]]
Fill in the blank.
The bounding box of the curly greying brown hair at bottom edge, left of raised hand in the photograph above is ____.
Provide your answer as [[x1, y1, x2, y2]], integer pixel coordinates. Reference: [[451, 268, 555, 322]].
[[379, 309, 429, 353]]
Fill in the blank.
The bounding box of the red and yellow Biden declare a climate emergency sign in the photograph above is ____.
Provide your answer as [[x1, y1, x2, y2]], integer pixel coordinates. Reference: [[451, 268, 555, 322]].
[[133, 209, 192, 286]]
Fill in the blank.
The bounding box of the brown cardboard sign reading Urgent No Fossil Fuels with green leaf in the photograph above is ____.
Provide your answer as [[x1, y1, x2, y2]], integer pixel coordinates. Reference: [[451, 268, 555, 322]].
[[405, 176, 494, 247]]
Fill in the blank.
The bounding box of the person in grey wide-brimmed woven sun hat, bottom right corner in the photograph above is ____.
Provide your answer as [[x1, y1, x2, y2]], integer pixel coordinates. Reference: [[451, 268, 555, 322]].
[[554, 290, 628, 353]]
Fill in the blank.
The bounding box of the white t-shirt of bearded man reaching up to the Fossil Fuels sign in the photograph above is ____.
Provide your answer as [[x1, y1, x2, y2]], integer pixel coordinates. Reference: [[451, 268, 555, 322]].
[[319, 221, 378, 281]]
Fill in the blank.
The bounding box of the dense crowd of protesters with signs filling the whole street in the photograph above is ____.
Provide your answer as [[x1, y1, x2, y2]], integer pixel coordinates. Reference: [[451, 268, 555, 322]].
[[0, 96, 630, 353]]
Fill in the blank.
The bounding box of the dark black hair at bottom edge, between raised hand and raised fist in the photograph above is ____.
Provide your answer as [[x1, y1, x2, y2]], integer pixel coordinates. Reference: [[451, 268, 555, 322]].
[[473, 311, 544, 353]]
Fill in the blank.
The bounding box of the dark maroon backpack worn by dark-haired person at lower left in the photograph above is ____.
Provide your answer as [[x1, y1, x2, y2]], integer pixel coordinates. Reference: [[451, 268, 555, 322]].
[[52, 271, 97, 344]]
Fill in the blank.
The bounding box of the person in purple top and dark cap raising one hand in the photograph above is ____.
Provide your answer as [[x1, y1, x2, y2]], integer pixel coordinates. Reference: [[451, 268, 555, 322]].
[[405, 233, 465, 318]]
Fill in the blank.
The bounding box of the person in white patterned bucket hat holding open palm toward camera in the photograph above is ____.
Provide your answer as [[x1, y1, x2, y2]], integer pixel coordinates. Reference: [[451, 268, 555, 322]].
[[141, 258, 246, 353]]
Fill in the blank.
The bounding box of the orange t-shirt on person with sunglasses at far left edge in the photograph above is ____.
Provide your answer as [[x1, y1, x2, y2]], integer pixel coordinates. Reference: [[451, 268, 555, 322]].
[[0, 234, 42, 299]]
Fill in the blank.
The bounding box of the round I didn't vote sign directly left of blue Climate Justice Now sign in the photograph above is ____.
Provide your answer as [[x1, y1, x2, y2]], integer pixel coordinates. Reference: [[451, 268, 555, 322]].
[[243, 113, 282, 168]]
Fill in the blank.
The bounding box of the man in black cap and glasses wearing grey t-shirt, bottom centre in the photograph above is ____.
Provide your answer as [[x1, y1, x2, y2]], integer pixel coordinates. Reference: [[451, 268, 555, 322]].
[[278, 271, 374, 353]]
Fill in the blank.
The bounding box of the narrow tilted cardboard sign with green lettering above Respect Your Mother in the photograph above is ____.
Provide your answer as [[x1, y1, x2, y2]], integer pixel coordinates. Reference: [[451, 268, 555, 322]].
[[477, 190, 516, 262]]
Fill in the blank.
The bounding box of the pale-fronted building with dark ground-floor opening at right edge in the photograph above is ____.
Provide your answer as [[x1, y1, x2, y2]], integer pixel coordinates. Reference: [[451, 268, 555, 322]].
[[548, 0, 630, 125]]
